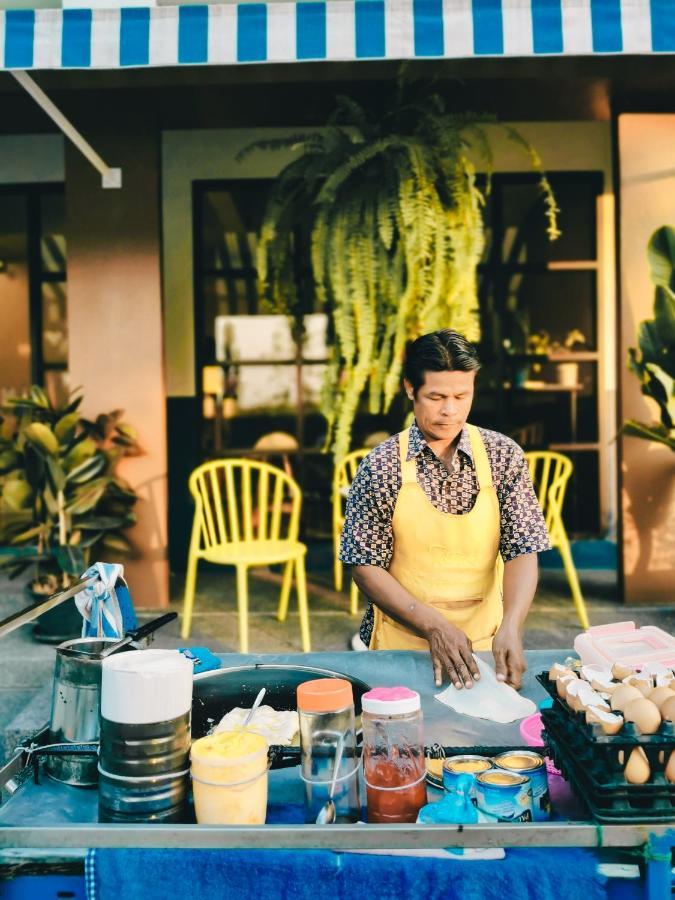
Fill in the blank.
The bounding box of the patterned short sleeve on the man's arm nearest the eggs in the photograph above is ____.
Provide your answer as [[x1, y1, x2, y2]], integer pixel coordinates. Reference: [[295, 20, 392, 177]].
[[497, 442, 551, 562]]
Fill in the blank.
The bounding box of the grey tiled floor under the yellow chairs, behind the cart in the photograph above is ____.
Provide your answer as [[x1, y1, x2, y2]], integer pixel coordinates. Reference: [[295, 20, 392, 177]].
[[0, 565, 675, 758]]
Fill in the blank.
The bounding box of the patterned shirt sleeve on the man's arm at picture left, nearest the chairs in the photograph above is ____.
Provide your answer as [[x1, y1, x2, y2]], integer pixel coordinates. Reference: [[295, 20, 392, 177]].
[[340, 457, 395, 569]]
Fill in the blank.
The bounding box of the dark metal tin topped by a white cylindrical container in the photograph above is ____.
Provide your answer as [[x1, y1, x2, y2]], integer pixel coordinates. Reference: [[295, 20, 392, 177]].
[[98, 650, 193, 823]]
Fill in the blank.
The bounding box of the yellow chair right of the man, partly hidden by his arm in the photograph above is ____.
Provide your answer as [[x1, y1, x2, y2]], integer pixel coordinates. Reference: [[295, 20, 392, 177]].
[[525, 450, 590, 628]]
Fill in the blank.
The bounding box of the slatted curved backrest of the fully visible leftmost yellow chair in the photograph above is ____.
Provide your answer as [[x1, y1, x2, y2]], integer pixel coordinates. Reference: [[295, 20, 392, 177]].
[[189, 459, 302, 550]]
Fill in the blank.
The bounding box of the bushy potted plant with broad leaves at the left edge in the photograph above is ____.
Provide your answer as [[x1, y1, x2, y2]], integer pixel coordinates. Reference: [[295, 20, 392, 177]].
[[0, 386, 141, 640]]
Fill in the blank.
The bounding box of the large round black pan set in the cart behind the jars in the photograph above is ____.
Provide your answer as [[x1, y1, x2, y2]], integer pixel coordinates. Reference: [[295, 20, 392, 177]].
[[192, 663, 370, 764]]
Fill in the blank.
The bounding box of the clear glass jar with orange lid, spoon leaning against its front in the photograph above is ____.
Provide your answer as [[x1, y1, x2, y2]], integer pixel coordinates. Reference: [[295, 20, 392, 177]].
[[297, 678, 361, 823]]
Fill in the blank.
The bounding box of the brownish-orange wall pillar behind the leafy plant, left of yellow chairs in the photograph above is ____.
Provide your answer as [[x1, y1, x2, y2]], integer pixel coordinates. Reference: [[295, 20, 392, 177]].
[[66, 118, 168, 606]]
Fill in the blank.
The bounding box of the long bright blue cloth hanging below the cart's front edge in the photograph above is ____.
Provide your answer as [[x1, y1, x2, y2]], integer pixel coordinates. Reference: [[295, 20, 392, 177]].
[[86, 844, 606, 900]]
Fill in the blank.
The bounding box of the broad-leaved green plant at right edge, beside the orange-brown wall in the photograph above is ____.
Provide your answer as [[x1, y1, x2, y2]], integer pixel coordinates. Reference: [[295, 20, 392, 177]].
[[623, 225, 675, 451]]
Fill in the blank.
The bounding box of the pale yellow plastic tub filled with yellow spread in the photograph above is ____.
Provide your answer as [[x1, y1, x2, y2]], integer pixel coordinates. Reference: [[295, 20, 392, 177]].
[[190, 730, 268, 825]]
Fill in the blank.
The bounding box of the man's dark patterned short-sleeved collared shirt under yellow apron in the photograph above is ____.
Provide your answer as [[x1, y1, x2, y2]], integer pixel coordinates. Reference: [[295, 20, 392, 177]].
[[340, 423, 551, 644]]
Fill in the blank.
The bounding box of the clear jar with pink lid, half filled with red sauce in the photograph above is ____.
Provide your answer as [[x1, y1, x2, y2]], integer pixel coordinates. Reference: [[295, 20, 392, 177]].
[[361, 687, 427, 823]]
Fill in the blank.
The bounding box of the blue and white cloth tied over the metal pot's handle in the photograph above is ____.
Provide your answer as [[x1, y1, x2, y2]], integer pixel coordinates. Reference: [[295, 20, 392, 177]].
[[75, 562, 138, 638]]
